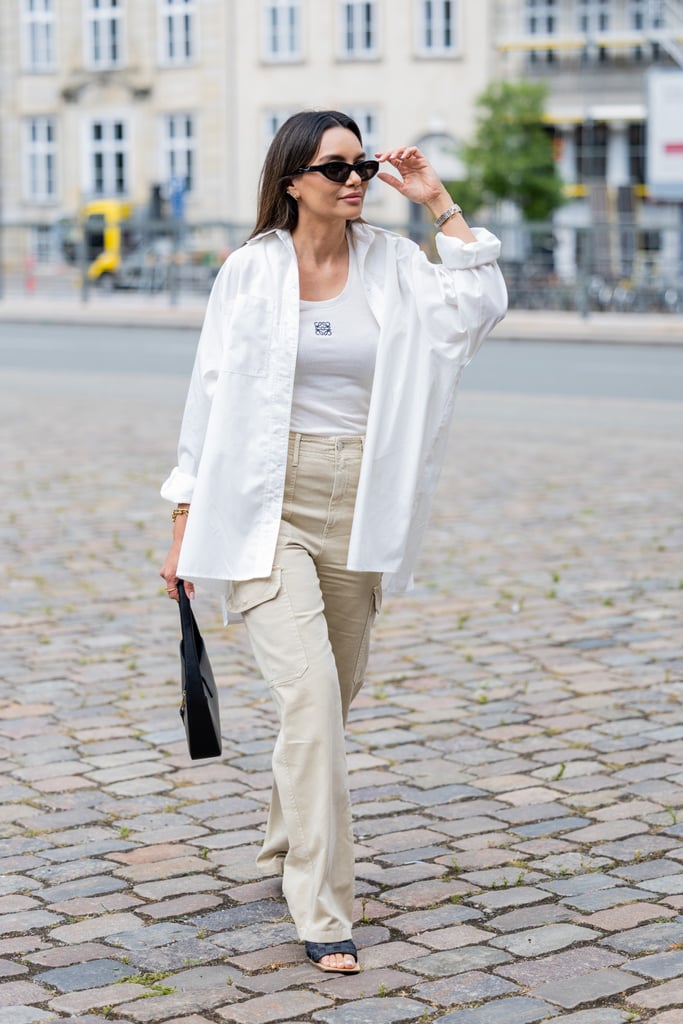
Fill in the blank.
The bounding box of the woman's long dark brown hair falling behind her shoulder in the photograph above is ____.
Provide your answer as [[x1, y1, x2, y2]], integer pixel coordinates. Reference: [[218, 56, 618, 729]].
[[249, 111, 362, 239]]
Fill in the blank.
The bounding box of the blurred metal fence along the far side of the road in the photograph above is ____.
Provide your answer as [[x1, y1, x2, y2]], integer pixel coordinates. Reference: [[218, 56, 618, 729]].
[[0, 220, 683, 314]]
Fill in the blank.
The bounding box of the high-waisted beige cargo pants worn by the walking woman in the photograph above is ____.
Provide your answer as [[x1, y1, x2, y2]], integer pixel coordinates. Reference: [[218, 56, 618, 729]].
[[229, 434, 381, 942]]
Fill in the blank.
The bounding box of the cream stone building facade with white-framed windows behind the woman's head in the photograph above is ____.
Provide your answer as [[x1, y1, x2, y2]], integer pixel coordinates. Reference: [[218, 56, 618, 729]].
[[0, 0, 494, 225]]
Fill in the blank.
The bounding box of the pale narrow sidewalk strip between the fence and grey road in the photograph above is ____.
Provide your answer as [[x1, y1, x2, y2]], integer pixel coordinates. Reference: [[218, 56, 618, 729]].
[[0, 293, 683, 345]]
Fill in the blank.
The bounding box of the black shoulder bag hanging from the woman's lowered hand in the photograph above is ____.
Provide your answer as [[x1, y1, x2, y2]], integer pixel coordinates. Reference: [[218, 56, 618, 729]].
[[178, 580, 222, 761]]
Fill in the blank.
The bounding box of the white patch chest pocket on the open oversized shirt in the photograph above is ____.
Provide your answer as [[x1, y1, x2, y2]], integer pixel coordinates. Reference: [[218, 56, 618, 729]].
[[220, 295, 273, 377]]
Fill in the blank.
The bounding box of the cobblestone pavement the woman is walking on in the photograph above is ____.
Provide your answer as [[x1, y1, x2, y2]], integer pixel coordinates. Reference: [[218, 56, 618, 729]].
[[0, 362, 683, 1024]]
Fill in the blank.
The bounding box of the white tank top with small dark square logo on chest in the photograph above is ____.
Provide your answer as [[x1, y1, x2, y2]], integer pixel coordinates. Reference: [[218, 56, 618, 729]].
[[290, 245, 379, 437]]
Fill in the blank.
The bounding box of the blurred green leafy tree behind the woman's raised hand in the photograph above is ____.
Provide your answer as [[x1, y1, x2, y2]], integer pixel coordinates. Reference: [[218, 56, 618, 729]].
[[451, 81, 564, 221]]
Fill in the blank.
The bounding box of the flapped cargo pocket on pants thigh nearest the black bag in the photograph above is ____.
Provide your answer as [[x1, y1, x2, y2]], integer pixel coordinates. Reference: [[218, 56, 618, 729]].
[[227, 568, 308, 686]]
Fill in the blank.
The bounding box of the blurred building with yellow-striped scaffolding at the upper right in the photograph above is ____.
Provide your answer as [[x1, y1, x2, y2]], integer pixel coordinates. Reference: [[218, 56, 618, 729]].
[[494, 0, 683, 278]]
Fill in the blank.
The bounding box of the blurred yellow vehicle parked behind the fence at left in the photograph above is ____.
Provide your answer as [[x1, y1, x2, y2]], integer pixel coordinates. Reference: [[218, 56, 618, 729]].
[[81, 199, 134, 288]]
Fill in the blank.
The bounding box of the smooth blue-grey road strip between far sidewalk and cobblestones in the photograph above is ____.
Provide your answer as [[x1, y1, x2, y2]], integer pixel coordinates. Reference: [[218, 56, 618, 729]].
[[0, 323, 683, 401]]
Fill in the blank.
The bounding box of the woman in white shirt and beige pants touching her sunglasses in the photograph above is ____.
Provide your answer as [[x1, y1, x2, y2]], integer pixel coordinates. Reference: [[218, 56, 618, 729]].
[[161, 111, 506, 974]]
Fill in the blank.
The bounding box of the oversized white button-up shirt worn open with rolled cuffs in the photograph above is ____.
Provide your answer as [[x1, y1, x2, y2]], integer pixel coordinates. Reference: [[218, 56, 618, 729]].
[[161, 223, 507, 591]]
